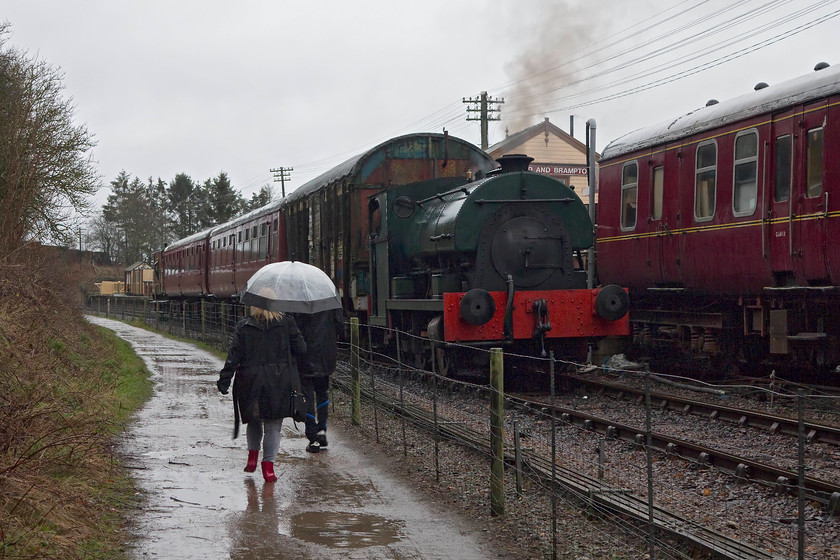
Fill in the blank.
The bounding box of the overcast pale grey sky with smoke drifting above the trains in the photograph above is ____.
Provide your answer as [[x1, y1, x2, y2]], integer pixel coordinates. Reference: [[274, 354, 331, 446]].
[[0, 0, 840, 211]]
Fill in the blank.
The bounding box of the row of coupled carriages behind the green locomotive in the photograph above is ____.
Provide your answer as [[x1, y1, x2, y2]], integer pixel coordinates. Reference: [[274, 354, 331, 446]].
[[157, 133, 496, 308]]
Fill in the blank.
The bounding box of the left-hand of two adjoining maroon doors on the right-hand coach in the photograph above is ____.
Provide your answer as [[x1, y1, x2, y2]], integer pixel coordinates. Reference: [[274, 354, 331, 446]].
[[761, 111, 798, 278]]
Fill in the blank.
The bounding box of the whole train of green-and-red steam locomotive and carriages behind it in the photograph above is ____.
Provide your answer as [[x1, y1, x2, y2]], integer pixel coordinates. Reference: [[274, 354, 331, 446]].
[[158, 133, 629, 373]]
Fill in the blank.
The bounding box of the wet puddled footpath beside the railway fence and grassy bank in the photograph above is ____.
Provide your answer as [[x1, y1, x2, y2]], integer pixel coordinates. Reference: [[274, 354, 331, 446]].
[[89, 317, 512, 560]]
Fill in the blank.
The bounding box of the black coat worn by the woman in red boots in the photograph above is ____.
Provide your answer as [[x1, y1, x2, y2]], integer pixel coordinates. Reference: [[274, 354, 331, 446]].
[[219, 314, 306, 424]]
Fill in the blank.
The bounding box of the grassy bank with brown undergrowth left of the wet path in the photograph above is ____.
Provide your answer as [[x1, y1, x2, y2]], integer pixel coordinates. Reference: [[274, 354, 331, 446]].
[[0, 255, 151, 560]]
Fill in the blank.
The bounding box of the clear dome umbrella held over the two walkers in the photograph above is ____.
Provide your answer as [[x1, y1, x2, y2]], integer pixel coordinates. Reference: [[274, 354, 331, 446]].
[[239, 261, 341, 313]]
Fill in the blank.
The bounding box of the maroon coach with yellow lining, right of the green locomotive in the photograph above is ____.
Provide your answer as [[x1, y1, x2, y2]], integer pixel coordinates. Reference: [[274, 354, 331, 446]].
[[597, 64, 840, 367]]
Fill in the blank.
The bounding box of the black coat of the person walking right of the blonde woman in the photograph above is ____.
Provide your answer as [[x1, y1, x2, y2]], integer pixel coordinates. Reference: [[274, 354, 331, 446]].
[[288, 309, 344, 377]]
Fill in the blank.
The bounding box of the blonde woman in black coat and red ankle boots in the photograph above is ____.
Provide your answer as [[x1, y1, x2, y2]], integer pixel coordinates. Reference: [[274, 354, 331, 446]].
[[216, 302, 306, 482]]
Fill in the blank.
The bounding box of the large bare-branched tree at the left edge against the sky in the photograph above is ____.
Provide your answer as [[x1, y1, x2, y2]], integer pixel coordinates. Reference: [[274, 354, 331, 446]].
[[0, 23, 99, 254]]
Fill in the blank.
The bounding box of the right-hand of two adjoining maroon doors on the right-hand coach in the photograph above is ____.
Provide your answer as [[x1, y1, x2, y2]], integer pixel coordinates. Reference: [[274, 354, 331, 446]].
[[792, 100, 828, 285]]
